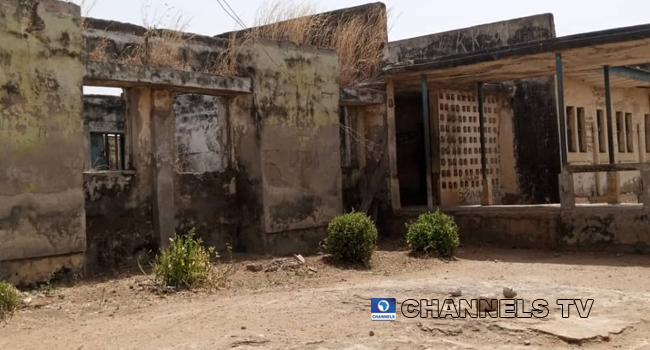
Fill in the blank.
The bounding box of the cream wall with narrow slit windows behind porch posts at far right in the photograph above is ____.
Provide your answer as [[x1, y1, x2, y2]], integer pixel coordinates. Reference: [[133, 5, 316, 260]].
[[564, 79, 650, 202]]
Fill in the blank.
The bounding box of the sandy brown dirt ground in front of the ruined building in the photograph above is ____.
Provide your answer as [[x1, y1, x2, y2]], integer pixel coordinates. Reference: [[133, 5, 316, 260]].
[[0, 241, 650, 350]]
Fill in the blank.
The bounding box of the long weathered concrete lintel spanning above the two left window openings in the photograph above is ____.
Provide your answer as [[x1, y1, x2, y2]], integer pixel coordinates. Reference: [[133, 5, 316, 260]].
[[84, 62, 252, 96]]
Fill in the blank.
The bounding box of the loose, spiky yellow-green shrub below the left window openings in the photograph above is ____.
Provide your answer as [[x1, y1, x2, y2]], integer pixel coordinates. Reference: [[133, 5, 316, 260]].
[[153, 229, 214, 288]]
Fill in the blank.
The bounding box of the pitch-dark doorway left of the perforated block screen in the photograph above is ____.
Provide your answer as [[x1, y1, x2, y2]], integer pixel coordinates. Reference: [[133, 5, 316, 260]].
[[395, 94, 427, 207]]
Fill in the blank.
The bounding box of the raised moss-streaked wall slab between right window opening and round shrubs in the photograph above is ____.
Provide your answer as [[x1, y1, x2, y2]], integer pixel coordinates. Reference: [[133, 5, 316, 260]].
[[248, 43, 342, 237]]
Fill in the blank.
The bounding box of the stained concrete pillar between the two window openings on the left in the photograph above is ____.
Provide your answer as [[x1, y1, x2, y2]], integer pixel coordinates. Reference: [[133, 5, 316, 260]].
[[151, 90, 176, 248]]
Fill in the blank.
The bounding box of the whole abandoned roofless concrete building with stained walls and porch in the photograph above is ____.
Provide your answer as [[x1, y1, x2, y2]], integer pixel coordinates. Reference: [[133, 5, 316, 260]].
[[0, 0, 650, 284]]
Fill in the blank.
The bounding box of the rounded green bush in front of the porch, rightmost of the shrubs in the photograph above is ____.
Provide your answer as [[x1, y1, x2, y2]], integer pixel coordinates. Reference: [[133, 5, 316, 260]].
[[406, 210, 460, 258]]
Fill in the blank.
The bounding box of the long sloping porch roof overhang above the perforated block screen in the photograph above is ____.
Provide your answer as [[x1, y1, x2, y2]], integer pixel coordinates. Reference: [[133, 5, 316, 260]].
[[384, 25, 650, 89]]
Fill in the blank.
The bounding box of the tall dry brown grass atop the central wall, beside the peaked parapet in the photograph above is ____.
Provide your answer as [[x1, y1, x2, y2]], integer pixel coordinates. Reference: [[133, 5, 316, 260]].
[[214, 0, 387, 86]]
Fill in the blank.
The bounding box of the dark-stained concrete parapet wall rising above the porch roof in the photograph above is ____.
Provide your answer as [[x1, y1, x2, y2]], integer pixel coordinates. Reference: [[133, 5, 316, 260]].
[[388, 14, 555, 63]]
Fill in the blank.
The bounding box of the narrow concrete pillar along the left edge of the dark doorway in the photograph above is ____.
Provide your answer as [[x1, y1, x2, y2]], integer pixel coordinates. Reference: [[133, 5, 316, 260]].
[[386, 79, 402, 210]]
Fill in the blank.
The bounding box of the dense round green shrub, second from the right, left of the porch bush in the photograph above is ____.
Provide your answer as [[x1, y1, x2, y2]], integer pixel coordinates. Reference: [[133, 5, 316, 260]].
[[324, 212, 377, 263]]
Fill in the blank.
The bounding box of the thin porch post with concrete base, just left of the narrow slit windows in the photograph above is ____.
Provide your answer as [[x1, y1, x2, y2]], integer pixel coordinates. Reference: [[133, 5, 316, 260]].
[[555, 53, 576, 209]]
